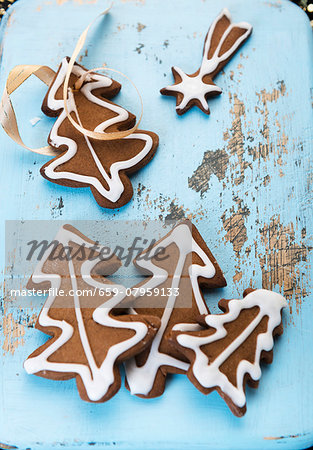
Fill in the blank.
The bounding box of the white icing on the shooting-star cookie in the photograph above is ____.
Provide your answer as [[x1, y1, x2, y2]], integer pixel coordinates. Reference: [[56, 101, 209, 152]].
[[165, 8, 252, 111]]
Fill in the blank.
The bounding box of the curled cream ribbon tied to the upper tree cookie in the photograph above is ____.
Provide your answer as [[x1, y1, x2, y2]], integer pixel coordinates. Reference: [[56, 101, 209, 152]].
[[0, 3, 143, 156]]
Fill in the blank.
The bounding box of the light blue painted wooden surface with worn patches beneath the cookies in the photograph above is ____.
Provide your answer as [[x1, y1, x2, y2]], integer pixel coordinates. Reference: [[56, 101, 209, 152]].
[[0, 0, 313, 450]]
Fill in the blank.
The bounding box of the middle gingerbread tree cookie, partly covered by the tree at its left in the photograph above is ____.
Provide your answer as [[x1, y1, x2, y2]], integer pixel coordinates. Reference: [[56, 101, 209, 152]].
[[125, 222, 226, 398]]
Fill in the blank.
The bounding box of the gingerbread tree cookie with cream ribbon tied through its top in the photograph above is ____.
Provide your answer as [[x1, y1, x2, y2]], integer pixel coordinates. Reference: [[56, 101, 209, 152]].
[[40, 58, 158, 208]]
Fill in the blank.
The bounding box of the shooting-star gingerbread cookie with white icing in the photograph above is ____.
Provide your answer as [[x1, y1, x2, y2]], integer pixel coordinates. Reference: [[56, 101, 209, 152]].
[[160, 8, 252, 115]]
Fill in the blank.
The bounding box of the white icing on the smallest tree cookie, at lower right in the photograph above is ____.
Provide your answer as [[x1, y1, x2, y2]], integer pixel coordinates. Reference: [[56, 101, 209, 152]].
[[177, 289, 287, 407]]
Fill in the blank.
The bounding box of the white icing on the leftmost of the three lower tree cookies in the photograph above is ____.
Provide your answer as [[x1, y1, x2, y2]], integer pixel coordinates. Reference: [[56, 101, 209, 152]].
[[24, 227, 148, 401]]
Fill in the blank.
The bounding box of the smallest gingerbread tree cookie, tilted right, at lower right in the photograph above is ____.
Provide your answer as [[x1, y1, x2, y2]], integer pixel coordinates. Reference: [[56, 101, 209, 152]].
[[171, 289, 287, 416]]
